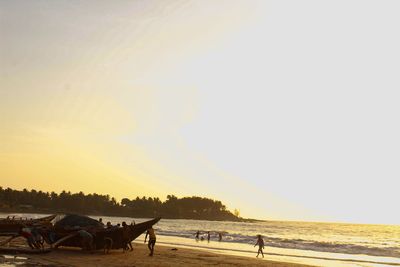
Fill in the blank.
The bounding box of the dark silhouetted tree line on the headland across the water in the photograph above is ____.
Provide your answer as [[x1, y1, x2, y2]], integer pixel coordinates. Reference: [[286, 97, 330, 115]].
[[0, 187, 242, 221]]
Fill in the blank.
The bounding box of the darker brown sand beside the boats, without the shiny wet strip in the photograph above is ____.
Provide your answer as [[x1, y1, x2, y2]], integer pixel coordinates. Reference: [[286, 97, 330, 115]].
[[0, 238, 306, 267]]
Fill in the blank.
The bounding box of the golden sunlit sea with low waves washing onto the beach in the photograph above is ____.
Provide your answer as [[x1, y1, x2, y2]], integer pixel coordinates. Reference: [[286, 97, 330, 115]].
[[1, 214, 400, 266]]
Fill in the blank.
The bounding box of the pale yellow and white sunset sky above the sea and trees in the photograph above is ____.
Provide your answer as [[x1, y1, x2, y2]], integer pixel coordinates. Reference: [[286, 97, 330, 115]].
[[0, 0, 400, 224]]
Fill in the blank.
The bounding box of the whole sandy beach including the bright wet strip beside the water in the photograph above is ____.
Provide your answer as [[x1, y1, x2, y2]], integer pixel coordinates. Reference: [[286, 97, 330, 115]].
[[0, 236, 400, 267]]
